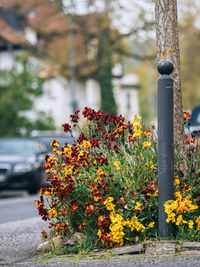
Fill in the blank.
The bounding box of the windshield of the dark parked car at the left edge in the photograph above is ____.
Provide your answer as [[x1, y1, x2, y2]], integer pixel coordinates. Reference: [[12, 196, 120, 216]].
[[0, 139, 34, 156]]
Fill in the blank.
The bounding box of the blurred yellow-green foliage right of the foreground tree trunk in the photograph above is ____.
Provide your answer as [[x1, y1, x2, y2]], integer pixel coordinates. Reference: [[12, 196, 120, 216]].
[[180, 11, 200, 110]]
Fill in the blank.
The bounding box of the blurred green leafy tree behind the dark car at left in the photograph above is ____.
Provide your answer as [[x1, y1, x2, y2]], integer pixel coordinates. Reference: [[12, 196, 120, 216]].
[[0, 57, 55, 136]]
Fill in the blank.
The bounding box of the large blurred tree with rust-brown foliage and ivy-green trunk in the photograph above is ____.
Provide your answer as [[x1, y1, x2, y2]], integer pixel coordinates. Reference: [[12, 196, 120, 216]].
[[2, 0, 153, 115]]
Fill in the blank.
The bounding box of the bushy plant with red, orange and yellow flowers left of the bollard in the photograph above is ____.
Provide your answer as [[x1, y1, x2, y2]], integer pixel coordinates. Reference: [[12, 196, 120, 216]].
[[36, 108, 198, 248]]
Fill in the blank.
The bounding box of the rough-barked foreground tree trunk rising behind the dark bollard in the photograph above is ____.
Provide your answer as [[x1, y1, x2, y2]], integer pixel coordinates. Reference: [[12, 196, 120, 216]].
[[155, 0, 187, 173]]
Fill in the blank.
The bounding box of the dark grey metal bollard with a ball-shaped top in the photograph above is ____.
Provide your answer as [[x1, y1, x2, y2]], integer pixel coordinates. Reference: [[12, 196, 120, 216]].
[[157, 60, 174, 239]]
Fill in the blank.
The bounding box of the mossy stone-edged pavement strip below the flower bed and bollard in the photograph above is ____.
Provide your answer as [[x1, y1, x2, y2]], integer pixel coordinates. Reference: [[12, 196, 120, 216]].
[[13, 241, 200, 267]]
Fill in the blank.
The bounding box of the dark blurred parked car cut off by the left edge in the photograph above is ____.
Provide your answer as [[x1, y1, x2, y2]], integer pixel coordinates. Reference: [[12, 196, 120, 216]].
[[0, 137, 48, 194]]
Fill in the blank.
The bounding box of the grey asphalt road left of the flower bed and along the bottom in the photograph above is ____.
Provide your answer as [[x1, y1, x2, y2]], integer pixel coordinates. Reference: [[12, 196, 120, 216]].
[[0, 192, 200, 267]]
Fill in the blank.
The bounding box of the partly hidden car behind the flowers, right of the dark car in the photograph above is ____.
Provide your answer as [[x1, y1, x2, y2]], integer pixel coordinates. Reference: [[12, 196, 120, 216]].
[[32, 131, 74, 152]]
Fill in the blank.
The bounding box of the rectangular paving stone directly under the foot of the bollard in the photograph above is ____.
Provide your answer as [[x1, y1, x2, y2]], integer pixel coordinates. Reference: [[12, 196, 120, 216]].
[[145, 242, 176, 255]]
